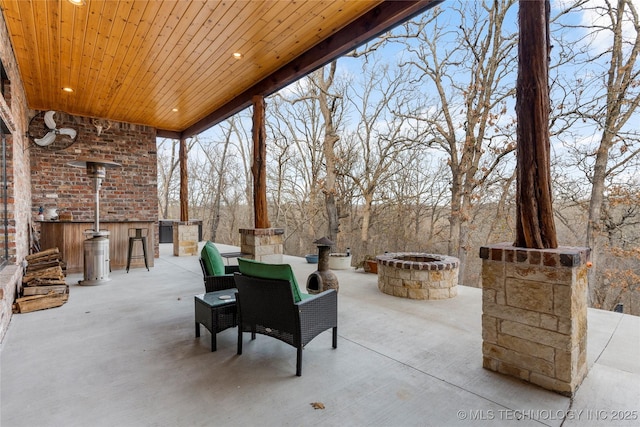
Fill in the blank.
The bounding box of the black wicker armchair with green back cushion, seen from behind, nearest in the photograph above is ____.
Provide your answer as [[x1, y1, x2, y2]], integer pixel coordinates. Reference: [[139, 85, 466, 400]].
[[234, 273, 338, 376]]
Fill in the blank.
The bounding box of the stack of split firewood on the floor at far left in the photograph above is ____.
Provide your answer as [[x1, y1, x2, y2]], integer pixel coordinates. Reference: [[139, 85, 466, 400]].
[[13, 248, 69, 313]]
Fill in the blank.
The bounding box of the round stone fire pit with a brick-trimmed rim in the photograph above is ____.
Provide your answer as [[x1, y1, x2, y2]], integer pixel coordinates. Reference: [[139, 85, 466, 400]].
[[376, 252, 460, 300]]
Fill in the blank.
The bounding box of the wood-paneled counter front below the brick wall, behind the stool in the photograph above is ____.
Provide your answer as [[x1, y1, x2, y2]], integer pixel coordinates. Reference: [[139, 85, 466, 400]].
[[40, 221, 156, 273]]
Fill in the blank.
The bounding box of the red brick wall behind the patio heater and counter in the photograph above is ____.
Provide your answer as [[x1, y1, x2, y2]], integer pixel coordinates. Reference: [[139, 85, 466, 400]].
[[29, 113, 159, 257]]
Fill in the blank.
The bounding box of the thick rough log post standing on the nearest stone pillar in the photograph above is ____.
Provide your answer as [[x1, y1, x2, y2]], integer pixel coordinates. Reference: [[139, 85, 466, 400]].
[[515, 0, 558, 249]]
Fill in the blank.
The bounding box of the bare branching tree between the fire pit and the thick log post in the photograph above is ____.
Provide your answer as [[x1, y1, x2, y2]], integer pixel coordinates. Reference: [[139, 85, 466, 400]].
[[405, 0, 517, 281]]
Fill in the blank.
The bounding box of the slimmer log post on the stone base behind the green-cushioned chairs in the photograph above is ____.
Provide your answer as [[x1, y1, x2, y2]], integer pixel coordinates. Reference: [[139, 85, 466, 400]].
[[251, 96, 271, 228]]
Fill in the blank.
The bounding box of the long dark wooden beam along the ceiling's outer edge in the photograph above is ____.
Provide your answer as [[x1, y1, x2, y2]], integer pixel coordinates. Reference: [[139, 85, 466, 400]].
[[182, 0, 444, 138]]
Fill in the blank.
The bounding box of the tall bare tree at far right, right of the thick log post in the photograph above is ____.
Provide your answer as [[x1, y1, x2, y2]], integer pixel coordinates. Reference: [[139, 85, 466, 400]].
[[557, 0, 640, 306]]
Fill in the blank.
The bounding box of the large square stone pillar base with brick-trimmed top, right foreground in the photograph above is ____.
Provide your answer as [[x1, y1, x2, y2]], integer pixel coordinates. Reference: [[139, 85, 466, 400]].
[[480, 243, 590, 396]]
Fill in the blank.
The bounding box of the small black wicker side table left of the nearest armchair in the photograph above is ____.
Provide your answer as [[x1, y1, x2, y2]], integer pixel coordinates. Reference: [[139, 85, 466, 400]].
[[194, 288, 238, 351]]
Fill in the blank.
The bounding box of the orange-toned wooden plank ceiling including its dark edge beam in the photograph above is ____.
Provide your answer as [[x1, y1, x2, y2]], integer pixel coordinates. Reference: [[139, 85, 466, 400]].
[[0, 0, 440, 137]]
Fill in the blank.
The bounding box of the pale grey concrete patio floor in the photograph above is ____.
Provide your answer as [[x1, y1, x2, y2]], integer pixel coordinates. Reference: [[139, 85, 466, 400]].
[[0, 244, 640, 427]]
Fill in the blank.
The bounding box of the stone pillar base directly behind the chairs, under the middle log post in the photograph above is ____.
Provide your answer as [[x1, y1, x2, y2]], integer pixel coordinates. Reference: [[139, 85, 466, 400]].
[[240, 228, 284, 264]]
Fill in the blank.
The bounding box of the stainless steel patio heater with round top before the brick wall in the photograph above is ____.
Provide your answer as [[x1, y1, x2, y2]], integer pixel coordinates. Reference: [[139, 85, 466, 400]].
[[68, 160, 122, 285]]
